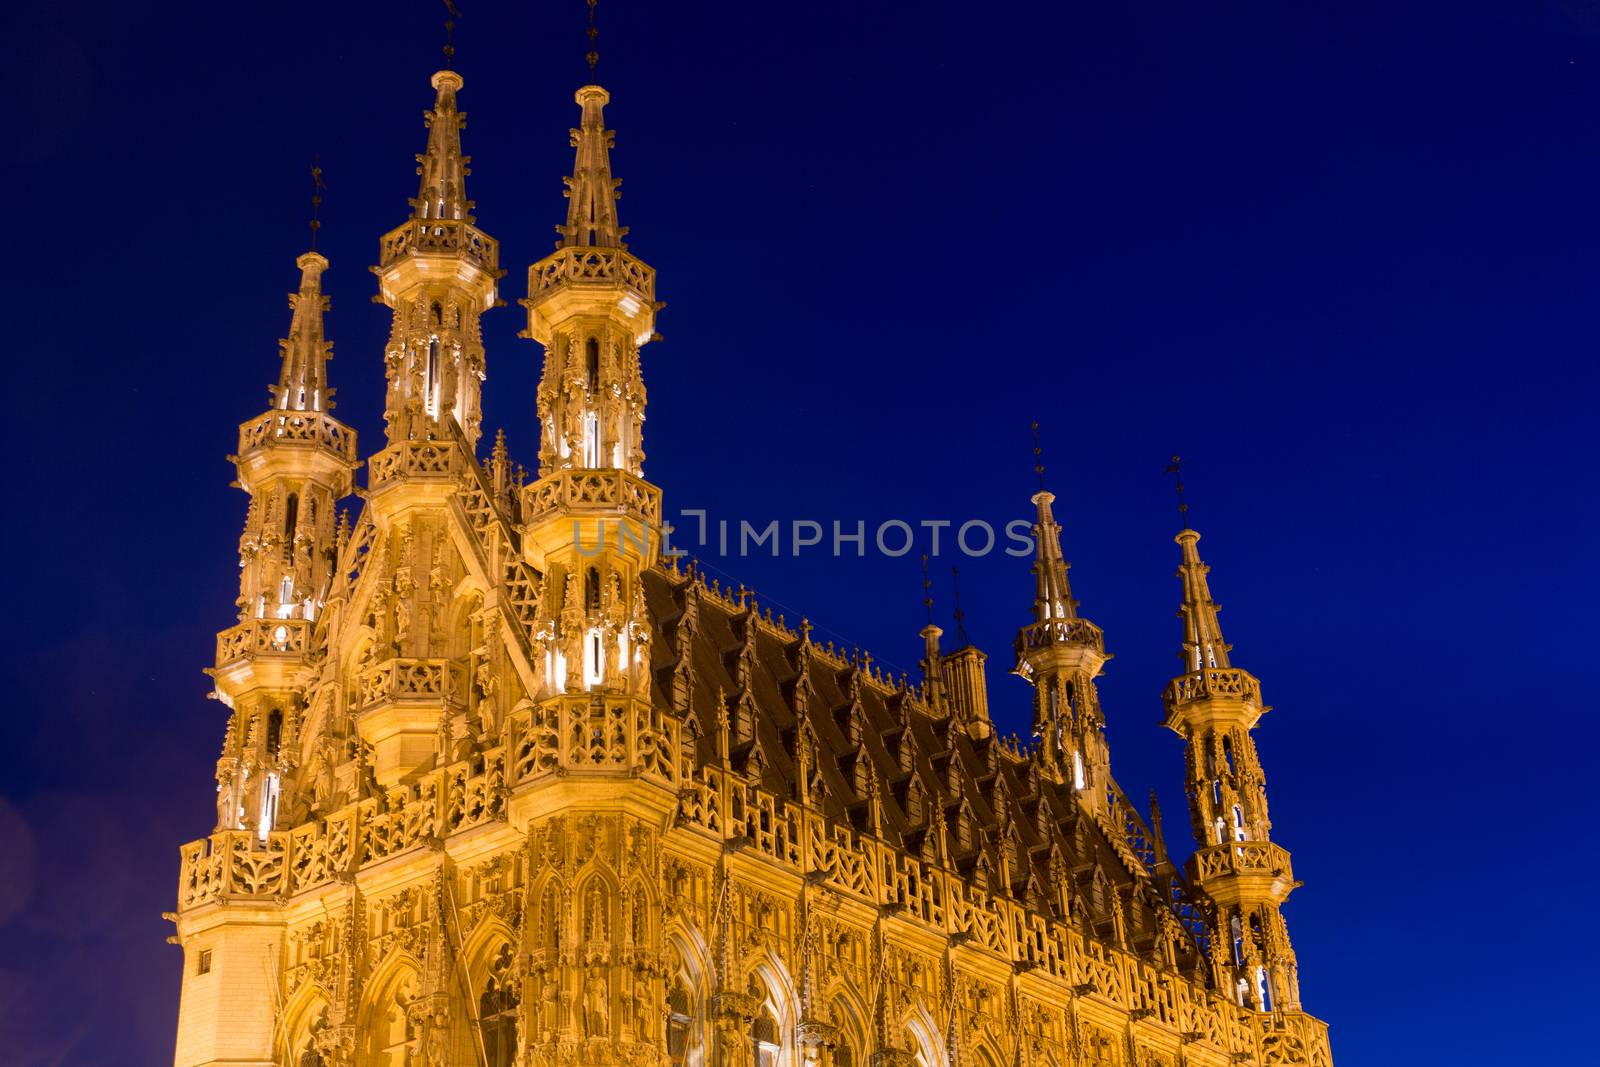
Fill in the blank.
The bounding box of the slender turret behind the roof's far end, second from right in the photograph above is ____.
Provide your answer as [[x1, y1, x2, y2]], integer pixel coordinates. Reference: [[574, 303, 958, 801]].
[[1013, 474, 1110, 811]]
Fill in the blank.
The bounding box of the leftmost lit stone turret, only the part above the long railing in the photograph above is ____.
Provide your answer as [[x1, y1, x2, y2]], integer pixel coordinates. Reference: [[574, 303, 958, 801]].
[[213, 251, 355, 833]]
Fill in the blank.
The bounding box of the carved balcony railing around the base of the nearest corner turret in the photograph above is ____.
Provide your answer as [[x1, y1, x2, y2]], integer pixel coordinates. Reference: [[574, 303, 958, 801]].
[[510, 693, 682, 789]]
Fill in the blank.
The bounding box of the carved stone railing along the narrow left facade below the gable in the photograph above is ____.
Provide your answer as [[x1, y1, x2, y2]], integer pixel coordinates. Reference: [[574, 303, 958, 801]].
[[178, 747, 506, 910]]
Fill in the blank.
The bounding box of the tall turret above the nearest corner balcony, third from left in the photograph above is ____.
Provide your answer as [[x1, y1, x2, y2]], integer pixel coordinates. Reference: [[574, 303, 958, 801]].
[[523, 85, 661, 699]]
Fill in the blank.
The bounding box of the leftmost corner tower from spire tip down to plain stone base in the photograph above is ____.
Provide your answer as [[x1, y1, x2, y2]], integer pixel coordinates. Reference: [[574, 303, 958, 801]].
[[180, 244, 355, 1067]]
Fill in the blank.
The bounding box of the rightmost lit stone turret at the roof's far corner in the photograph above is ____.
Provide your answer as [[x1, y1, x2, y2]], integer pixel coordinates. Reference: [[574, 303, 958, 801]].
[[1163, 526, 1301, 1011]]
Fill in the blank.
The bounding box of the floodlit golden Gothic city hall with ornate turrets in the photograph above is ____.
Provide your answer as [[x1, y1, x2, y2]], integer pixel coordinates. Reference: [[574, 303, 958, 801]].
[[170, 54, 1331, 1067]]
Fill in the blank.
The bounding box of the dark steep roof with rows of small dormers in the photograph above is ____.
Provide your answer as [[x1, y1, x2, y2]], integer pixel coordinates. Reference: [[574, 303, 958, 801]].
[[645, 568, 1208, 971]]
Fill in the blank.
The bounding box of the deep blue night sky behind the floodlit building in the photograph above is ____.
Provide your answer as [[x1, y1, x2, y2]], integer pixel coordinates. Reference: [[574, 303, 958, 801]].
[[0, 0, 1600, 1067]]
